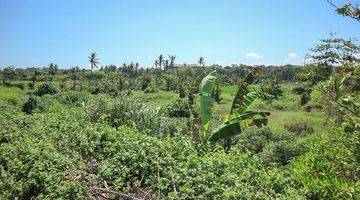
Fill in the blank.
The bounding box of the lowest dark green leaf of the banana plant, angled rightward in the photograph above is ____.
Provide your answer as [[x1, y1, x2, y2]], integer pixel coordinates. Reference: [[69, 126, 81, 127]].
[[209, 122, 241, 142]]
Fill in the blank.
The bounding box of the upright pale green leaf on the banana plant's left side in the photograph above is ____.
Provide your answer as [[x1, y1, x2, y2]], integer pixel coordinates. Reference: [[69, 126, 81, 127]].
[[199, 71, 216, 134]]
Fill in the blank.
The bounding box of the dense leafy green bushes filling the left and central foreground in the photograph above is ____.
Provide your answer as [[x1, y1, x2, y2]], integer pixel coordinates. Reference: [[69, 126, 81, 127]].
[[0, 102, 302, 199]]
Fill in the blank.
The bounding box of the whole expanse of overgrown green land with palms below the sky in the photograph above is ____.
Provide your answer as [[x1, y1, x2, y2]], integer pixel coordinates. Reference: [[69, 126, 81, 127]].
[[0, 33, 360, 199]]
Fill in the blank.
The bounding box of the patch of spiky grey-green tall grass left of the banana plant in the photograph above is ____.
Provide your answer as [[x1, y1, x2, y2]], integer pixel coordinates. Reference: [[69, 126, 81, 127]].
[[85, 95, 187, 136]]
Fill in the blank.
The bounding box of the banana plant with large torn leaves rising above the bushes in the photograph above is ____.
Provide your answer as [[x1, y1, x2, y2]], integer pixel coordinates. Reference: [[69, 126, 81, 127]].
[[198, 68, 270, 142]]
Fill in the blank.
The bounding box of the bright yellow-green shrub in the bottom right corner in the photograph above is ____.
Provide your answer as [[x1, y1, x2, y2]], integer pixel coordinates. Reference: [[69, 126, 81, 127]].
[[293, 129, 360, 200]]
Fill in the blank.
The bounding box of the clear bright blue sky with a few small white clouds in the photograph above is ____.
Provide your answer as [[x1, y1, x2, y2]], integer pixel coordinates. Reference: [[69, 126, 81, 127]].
[[0, 0, 360, 68]]
